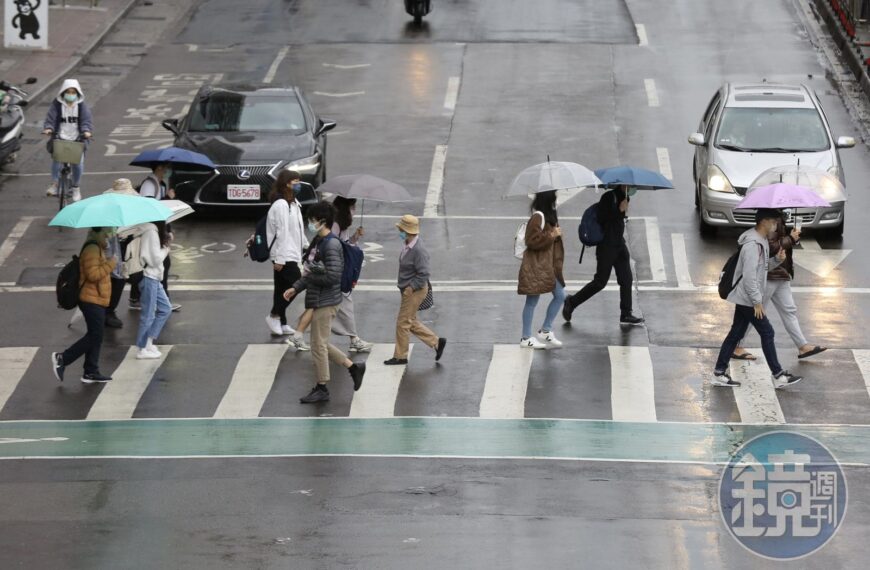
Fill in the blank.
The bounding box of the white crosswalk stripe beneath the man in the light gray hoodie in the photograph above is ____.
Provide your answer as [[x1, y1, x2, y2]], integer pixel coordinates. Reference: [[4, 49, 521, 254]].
[[732, 354, 785, 424]]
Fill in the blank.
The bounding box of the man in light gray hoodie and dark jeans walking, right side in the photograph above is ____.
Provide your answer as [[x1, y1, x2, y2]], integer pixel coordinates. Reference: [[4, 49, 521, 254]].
[[713, 209, 802, 389]]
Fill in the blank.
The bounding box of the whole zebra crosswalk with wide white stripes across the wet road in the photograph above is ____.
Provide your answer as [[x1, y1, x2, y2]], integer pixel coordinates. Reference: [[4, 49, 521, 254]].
[[0, 343, 870, 424]]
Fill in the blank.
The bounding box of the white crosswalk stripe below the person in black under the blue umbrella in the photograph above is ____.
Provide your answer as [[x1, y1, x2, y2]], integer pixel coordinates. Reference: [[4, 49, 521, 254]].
[[607, 346, 656, 422]]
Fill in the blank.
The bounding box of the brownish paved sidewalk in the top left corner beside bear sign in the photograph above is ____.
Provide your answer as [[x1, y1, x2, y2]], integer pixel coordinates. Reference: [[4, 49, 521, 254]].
[[0, 0, 139, 99]]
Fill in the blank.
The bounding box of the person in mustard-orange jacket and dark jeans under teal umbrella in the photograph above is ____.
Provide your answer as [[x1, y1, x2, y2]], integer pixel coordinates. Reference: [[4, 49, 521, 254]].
[[51, 228, 118, 384]]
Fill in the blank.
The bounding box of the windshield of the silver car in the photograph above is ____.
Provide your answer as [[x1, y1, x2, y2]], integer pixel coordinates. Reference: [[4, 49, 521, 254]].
[[716, 107, 831, 152]]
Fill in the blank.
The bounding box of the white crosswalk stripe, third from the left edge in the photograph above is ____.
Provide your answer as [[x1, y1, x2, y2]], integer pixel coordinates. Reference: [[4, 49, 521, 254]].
[[214, 343, 287, 418]]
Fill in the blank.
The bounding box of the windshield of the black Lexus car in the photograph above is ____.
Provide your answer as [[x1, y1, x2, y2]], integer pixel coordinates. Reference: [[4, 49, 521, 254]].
[[188, 91, 305, 133]]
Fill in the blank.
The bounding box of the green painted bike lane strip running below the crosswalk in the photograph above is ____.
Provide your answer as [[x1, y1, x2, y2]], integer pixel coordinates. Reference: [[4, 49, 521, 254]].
[[0, 418, 870, 465]]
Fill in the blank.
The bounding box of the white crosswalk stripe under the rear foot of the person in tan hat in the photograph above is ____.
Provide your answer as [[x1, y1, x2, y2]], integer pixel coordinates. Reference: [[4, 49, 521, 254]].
[[350, 344, 414, 418]]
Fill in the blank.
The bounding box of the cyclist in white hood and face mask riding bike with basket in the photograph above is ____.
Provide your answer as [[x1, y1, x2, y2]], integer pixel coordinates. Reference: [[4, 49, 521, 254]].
[[42, 79, 94, 202]]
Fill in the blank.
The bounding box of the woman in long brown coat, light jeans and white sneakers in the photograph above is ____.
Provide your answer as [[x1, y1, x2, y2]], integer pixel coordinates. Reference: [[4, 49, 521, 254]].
[[517, 190, 565, 348]]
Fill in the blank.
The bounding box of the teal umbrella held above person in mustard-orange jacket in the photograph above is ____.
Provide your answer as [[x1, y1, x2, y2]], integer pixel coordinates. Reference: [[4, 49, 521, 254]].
[[48, 194, 172, 228]]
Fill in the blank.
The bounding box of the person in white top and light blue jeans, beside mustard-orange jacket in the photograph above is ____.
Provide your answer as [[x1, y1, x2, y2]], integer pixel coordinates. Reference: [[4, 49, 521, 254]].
[[136, 222, 172, 360]]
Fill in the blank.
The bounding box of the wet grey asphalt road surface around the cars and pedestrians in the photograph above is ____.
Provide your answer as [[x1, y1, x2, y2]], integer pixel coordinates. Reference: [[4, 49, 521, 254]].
[[0, 0, 870, 568]]
